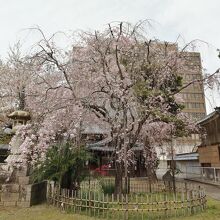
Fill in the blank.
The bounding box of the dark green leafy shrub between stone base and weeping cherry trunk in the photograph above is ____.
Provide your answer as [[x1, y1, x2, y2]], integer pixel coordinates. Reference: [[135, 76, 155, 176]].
[[31, 142, 90, 190]]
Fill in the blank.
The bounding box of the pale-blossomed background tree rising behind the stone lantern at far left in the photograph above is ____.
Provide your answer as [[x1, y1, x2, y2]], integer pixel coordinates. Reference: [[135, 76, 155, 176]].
[[0, 42, 34, 112]]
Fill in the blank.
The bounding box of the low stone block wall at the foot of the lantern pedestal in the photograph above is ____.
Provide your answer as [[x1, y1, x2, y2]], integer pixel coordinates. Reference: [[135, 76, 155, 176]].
[[0, 181, 47, 207]]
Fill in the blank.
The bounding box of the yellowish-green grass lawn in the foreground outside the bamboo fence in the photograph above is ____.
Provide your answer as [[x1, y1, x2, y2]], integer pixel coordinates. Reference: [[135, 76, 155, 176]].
[[0, 199, 220, 220]]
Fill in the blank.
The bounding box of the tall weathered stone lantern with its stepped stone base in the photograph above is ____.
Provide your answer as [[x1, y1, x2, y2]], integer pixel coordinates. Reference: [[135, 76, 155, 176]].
[[0, 110, 42, 207]]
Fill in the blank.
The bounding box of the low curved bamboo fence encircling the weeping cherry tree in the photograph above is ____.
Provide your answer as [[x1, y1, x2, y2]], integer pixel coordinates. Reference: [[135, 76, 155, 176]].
[[48, 182, 206, 220]]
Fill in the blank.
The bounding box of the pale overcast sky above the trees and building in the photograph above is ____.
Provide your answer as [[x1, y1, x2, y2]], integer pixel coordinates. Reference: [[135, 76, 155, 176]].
[[0, 0, 220, 112]]
